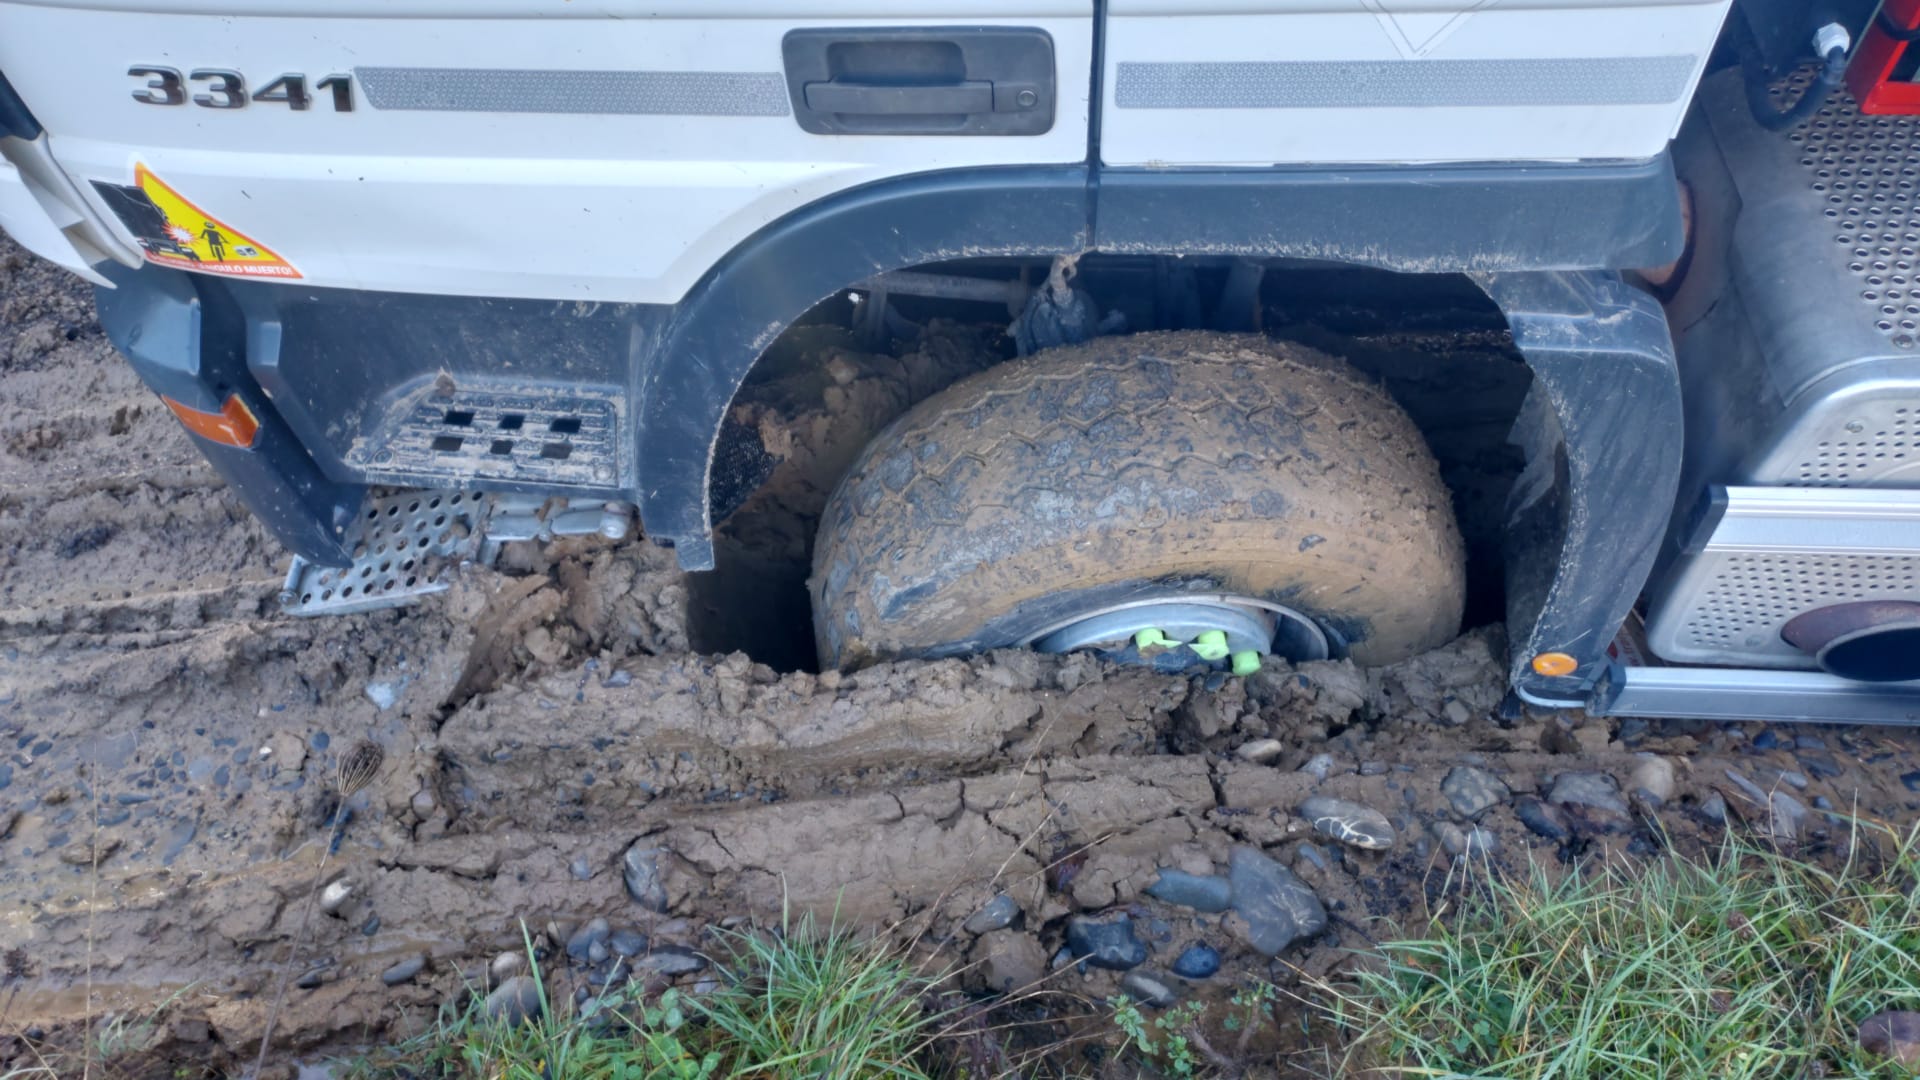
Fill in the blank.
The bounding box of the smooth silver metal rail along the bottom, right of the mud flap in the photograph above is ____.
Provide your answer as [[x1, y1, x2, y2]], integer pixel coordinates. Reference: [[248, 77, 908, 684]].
[[1588, 667, 1920, 726]]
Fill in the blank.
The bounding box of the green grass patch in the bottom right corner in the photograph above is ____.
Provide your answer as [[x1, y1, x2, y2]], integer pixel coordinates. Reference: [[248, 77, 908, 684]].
[[1323, 822, 1920, 1080]]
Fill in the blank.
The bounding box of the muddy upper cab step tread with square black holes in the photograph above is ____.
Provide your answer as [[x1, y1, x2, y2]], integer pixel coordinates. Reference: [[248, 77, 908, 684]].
[[348, 382, 628, 488]]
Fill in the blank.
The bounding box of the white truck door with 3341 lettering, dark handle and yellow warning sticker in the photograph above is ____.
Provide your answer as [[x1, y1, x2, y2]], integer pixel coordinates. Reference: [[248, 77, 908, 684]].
[[0, 0, 1094, 304]]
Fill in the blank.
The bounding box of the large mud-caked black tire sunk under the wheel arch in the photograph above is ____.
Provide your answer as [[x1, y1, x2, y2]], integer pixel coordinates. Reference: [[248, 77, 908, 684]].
[[808, 332, 1465, 669]]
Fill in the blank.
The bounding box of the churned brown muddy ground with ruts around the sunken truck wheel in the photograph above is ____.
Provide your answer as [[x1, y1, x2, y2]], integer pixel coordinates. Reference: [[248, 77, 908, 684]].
[[0, 237, 1920, 1072]]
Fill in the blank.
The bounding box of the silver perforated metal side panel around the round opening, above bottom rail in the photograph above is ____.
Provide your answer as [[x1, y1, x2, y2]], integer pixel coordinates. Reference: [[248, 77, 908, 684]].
[[1647, 480, 1920, 671]]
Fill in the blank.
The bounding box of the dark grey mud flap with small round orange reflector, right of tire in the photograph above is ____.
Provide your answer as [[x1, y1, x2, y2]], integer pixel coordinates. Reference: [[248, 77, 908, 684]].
[[1475, 271, 1682, 707]]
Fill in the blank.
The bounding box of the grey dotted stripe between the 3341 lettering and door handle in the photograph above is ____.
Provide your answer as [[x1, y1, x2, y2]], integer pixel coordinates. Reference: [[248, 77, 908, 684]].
[[353, 67, 787, 115]]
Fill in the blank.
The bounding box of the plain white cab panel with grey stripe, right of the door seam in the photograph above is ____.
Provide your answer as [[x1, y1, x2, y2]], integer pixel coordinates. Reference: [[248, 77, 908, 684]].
[[1100, 0, 1728, 165]]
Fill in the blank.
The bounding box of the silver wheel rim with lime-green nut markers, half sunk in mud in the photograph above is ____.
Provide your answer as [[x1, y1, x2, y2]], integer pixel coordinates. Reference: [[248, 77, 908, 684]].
[[1023, 594, 1332, 673]]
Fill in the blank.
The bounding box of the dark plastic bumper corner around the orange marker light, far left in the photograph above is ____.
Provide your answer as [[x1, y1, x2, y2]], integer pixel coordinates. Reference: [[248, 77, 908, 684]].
[[94, 265, 367, 567]]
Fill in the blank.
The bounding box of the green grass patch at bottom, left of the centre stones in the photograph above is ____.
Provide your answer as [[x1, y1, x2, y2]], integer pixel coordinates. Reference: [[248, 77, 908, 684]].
[[344, 919, 941, 1080]]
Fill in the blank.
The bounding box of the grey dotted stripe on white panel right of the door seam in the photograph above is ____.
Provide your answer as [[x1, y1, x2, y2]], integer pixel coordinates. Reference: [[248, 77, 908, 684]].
[[1114, 56, 1699, 110]]
